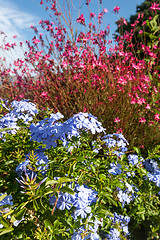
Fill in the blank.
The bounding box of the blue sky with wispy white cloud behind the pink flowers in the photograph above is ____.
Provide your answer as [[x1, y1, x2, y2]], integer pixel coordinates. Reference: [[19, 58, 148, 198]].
[[0, 0, 144, 65]]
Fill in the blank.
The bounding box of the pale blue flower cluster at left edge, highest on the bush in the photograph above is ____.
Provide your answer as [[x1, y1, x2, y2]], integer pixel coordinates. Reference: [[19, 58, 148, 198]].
[[0, 100, 38, 138]]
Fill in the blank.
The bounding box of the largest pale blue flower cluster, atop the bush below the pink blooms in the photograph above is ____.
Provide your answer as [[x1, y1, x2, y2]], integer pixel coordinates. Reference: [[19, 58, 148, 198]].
[[30, 112, 105, 150]]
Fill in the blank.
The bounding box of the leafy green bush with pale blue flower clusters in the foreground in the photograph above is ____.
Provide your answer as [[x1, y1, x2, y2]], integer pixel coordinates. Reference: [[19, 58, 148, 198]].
[[0, 100, 160, 240]]
